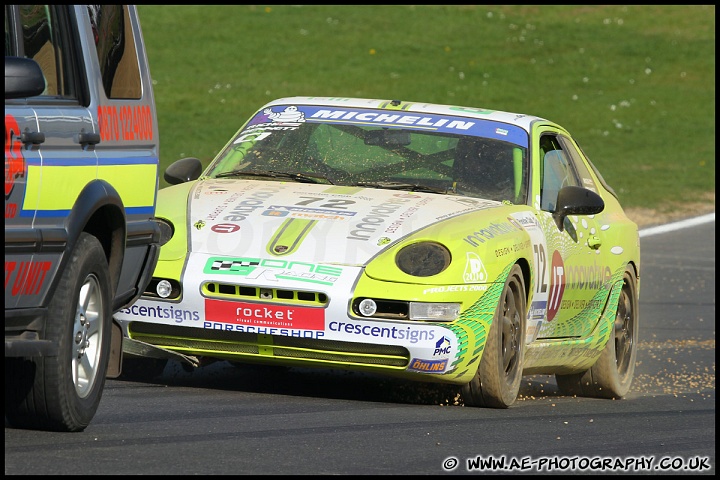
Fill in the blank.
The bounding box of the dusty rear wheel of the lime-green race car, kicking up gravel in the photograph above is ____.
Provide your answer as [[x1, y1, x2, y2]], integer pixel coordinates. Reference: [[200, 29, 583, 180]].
[[555, 266, 640, 398]]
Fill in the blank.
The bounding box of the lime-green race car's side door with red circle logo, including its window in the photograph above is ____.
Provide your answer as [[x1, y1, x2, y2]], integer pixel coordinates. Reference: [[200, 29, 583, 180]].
[[537, 129, 610, 338]]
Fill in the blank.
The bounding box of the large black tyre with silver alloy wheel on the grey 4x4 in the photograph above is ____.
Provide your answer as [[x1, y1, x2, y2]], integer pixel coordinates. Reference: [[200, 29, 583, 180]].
[[5, 233, 112, 432]]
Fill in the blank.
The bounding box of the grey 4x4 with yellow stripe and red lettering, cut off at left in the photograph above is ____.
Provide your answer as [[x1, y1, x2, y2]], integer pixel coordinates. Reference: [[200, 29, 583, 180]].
[[5, 5, 161, 431]]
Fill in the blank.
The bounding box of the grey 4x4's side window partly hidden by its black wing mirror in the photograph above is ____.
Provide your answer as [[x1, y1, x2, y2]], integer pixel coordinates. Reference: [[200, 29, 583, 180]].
[[17, 5, 67, 98]]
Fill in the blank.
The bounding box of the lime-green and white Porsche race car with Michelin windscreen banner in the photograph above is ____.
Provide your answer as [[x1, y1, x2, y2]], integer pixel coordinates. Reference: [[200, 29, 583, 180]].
[[117, 97, 640, 408]]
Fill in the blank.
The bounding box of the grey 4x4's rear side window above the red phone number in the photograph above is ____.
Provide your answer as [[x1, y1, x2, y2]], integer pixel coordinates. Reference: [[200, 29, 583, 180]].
[[87, 5, 142, 99]]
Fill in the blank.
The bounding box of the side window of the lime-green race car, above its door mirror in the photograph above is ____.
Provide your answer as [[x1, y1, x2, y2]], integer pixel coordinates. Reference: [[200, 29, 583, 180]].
[[540, 135, 580, 211]]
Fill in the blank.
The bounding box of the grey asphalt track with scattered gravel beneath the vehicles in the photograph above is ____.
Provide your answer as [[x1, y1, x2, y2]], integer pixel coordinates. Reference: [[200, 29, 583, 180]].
[[5, 214, 715, 475]]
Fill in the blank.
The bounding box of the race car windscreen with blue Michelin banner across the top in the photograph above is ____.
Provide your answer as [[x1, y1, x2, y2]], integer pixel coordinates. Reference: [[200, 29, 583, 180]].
[[208, 105, 528, 204]]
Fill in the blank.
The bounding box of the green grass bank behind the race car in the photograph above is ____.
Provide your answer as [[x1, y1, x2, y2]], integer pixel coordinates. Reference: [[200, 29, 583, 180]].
[[138, 5, 715, 215]]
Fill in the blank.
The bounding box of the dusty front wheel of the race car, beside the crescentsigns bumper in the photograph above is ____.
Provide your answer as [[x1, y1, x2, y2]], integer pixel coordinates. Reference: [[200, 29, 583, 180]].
[[462, 265, 527, 408]]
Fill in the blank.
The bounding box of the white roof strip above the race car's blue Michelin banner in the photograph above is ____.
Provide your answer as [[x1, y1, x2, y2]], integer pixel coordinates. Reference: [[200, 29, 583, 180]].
[[261, 96, 562, 132]]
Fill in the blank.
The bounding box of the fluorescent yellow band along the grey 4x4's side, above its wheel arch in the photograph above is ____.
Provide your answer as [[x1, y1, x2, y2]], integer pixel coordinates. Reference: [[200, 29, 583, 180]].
[[23, 164, 157, 210]]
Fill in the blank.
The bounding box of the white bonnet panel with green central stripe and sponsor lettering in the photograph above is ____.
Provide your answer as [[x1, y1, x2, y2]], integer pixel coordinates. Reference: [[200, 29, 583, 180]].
[[187, 179, 500, 265]]
